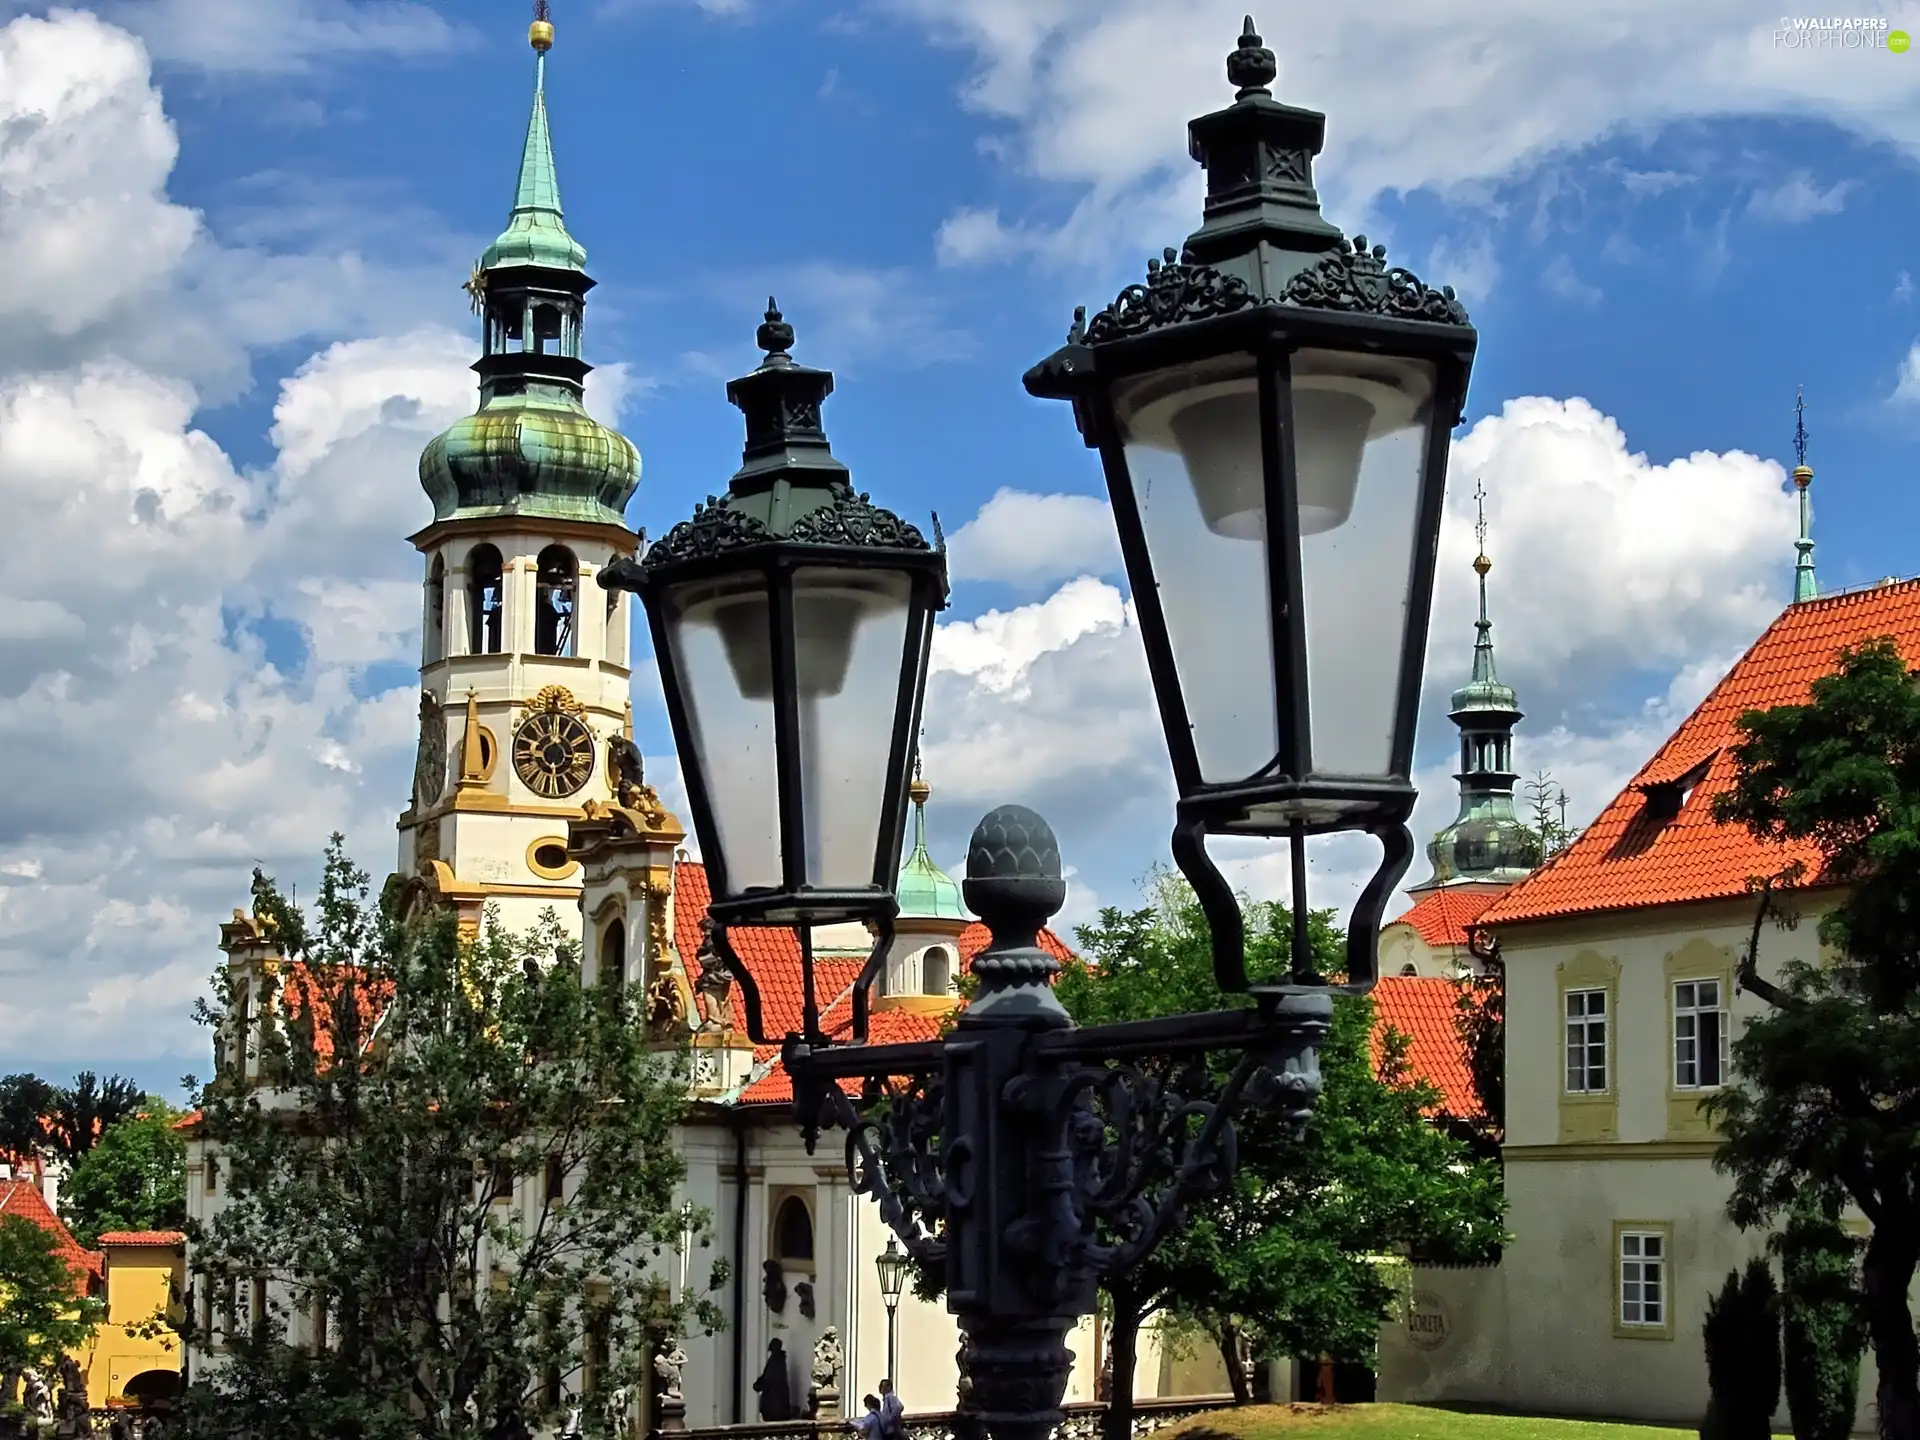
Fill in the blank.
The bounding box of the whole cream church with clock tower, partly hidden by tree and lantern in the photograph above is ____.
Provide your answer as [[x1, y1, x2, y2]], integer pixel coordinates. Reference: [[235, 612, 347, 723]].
[[176, 23, 1225, 1428]]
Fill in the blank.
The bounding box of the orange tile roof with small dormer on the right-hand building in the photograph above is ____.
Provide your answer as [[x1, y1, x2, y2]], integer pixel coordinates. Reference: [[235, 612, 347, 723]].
[[1480, 580, 1920, 925]]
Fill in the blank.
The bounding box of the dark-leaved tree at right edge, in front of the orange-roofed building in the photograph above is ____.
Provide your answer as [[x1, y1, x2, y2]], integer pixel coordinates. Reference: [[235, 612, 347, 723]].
[[1709, 637, 1920, 1440]]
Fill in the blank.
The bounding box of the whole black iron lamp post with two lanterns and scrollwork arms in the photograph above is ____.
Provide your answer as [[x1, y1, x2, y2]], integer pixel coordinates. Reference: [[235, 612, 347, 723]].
[[599, 21, 1475, 1440]]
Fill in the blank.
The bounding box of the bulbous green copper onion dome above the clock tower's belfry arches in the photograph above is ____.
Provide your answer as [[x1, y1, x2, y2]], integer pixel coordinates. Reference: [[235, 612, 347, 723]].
[[420, 384, 639, 524]]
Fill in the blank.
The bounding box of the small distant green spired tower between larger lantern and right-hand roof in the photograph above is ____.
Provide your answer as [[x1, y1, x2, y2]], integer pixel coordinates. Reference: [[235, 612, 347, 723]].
[[1409, 490, 1542, 895]]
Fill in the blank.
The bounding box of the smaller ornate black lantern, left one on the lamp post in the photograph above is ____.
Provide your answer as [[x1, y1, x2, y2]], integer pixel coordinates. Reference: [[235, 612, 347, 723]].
[[599, 300, 947, 1037]]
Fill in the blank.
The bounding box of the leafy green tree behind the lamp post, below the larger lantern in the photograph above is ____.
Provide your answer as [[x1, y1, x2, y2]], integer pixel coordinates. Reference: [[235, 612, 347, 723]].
[[1056, 872, 1503, 1436]]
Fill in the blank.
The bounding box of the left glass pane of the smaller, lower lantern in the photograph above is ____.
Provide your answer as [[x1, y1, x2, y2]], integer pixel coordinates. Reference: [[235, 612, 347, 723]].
[[664, 572, 781, 895]]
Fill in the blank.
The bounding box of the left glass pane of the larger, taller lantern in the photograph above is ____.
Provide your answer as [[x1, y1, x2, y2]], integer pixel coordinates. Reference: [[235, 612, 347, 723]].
[[1114, 355, 1281, 783]]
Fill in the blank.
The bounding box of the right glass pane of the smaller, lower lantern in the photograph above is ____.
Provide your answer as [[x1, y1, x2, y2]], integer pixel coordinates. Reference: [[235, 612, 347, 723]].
[[793, 566, 912, 889]]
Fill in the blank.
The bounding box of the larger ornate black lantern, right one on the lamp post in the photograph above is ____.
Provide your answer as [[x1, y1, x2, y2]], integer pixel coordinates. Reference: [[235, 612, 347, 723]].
[[1025, 17, 1476, 991]]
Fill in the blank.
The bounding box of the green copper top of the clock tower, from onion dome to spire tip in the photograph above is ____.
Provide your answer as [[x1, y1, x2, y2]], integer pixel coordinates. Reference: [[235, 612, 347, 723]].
[[420, 21, 639, 524]]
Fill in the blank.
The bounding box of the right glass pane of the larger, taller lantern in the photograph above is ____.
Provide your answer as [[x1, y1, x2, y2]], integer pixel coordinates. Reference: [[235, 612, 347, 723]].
[[1292, 349, 1434, 776]]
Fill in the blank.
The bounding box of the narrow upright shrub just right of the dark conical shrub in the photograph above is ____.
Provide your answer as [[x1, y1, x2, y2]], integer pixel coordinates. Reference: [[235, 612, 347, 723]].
[[1768, 1190, 1866, 1440]]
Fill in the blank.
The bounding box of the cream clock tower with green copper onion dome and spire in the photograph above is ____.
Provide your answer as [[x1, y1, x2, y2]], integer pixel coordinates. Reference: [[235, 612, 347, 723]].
[[399, 6, 639, 929]]
